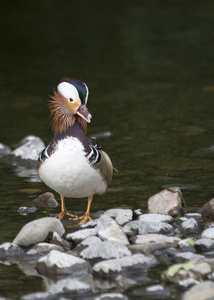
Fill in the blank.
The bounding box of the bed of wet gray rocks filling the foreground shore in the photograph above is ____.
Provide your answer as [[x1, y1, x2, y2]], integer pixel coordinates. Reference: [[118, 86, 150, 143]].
[[0, 189, 214, 300]]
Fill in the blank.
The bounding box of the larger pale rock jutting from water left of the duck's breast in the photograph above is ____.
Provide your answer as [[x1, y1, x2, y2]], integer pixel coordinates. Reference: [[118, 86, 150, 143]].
[[12, 135, 45, 161]]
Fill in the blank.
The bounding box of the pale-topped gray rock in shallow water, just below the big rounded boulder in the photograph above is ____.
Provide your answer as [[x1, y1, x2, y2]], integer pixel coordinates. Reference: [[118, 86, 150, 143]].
[[36, 250, 89, 277]]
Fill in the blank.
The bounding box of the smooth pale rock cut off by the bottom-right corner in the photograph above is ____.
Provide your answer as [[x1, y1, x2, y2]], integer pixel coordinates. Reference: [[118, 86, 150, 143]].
[[182, 280, 214, 300]]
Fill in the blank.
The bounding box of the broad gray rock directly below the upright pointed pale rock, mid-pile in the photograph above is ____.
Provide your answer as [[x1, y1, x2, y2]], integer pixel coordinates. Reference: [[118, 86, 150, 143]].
[[80, 241, 132, 260]]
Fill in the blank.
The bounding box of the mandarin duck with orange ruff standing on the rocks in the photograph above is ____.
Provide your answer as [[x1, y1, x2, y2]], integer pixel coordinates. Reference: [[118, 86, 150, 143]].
[[37, 78, 113, 225]]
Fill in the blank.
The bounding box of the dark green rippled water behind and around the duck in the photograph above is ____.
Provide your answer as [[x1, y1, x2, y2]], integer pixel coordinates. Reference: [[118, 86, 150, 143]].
[[0, 0, 214, 297]]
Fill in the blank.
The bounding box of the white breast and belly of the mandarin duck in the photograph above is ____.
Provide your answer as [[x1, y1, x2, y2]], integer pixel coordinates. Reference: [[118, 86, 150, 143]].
[[38, 137, 106, 198]]
